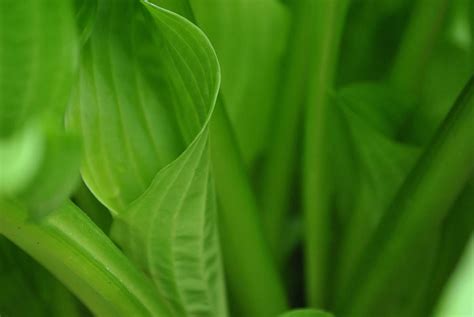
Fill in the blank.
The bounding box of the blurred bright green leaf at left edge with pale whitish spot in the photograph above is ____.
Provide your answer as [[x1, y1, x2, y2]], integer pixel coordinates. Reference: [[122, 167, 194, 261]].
[[0, 0, 79, 211]]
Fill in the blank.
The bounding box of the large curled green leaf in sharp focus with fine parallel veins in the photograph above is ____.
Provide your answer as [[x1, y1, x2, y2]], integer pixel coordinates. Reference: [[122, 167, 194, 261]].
[[69, 0, 226, 316]]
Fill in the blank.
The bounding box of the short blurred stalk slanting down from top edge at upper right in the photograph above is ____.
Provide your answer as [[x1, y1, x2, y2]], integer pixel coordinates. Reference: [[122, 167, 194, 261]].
[[390, 0, 451, 96]]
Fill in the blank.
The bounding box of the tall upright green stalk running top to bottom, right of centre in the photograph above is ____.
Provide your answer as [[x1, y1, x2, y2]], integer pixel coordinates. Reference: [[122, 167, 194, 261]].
[[302, 0, 349, 307]]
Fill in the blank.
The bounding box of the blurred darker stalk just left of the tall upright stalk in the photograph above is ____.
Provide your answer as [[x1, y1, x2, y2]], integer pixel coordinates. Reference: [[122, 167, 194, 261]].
[[261, 1, 314, 262]]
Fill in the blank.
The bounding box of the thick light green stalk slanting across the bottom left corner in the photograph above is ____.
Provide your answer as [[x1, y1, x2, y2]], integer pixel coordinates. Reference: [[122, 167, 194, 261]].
[[0, 199, 170, 317]]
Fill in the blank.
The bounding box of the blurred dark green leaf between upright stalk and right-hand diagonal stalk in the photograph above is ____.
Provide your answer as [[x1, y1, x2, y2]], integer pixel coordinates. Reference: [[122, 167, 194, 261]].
[[332, 83, 420, 298]]
